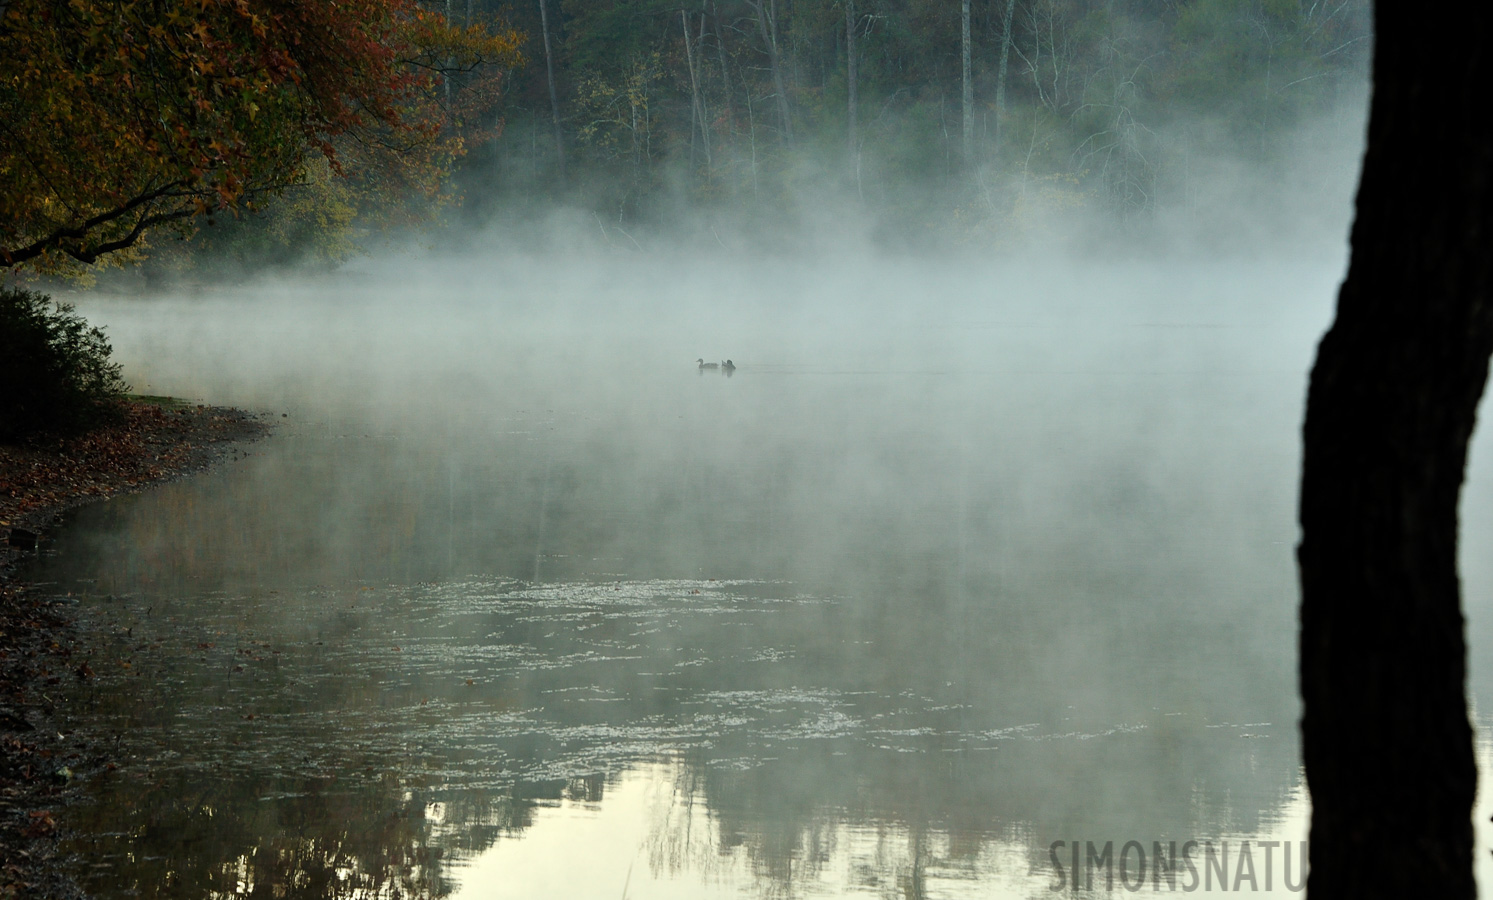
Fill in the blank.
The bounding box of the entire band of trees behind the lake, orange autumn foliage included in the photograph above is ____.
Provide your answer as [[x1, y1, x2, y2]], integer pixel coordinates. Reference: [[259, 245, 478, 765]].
[[0, 0, 1372, 270]]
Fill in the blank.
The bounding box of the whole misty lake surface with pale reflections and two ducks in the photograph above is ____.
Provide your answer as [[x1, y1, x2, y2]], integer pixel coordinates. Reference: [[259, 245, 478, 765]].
[[27, 257, 1493, 900]]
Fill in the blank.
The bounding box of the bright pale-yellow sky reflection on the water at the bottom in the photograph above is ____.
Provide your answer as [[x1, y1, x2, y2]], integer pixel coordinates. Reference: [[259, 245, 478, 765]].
[[444, 764, 1308, 900]]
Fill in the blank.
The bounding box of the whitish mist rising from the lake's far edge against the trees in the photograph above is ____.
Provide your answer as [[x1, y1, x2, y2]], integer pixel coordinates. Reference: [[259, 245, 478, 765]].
[[122, 94, 1366, 286]]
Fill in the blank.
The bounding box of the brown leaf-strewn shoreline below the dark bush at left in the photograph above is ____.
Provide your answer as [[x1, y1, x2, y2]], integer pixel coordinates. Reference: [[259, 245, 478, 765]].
[[0, 397, 272, 900]]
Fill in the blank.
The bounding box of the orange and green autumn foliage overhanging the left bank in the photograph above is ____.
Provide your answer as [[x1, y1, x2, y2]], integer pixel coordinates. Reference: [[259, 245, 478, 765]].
[[0, 0, 520, 269]]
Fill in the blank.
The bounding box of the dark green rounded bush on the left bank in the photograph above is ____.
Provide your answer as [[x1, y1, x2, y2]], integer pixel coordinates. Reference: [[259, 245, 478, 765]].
[[0, 288, 130, 440]]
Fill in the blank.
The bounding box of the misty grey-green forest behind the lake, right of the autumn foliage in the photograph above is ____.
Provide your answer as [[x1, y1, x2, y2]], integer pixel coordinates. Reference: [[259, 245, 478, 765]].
[[454, 0, 1372, 235]]
